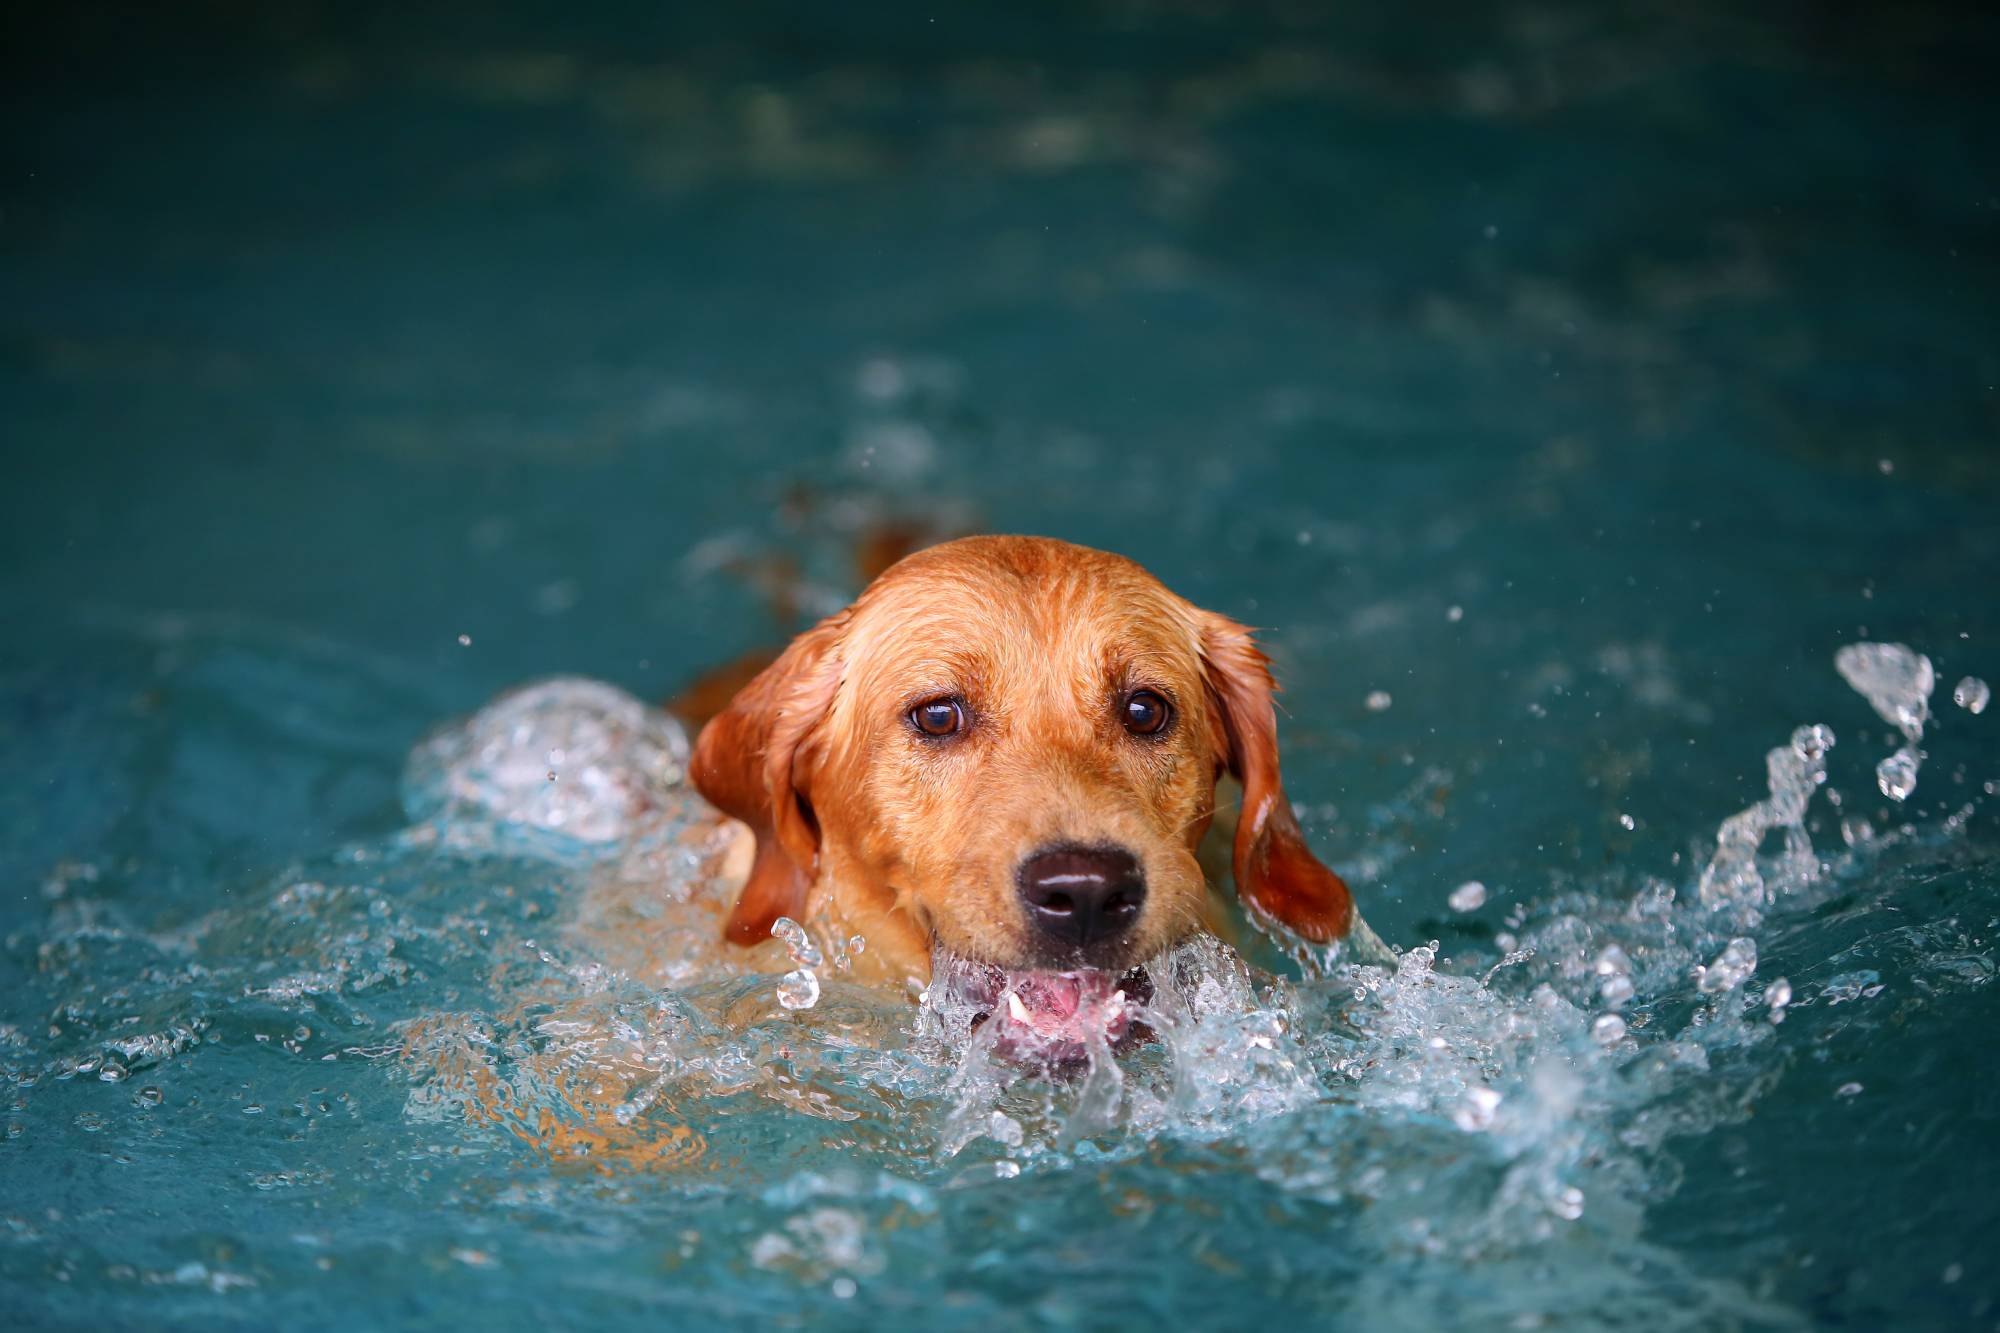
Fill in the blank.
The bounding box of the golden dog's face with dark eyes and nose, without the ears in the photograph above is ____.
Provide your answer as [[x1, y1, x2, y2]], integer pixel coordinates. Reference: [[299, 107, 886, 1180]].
[[814, 544, 1228, 969]]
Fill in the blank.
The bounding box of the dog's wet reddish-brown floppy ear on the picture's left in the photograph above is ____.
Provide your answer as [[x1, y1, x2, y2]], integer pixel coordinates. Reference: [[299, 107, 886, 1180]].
[[690, 610, 848, 945]]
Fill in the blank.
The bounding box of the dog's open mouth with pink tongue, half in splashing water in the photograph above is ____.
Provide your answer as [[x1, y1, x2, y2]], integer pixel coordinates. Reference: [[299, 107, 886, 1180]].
[[934, 959, 1152, 1061]]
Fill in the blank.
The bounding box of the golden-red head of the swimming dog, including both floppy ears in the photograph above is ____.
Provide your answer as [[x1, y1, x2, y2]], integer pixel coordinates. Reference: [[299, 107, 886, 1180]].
[[694, 536, 1354, 992]]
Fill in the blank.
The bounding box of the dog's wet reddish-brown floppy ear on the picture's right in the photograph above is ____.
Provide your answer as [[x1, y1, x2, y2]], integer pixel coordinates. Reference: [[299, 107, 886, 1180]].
[[1202, 612, 1354, 943]]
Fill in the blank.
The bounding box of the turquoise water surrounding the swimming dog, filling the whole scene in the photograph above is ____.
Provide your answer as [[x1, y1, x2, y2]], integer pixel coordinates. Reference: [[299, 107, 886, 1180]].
[[0, 6, 2000, 1329]]
